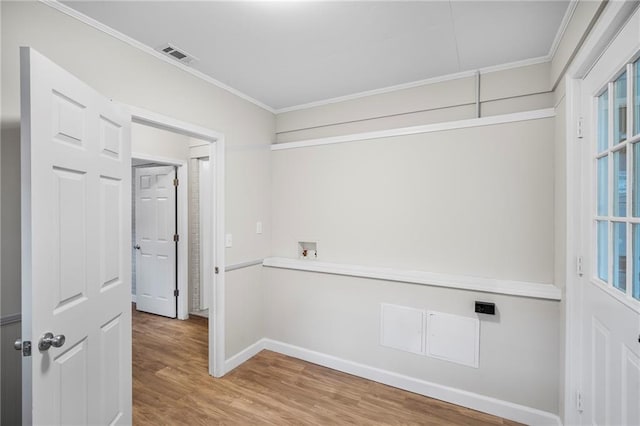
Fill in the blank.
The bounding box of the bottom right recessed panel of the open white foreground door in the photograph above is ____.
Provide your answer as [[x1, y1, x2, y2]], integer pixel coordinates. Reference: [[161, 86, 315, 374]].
[[100, 315, 123, 424]]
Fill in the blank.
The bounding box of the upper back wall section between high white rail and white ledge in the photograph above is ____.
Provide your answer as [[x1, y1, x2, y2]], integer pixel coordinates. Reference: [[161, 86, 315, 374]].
[[272, 119, 554, 283]]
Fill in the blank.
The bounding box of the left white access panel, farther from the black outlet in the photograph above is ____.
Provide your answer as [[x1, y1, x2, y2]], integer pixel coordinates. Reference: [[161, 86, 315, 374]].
[[380, 303, 425, 355]]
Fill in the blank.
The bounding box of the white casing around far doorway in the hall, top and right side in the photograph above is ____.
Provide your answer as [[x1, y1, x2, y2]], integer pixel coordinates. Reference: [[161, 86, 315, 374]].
[[131, 153, 189, 320]]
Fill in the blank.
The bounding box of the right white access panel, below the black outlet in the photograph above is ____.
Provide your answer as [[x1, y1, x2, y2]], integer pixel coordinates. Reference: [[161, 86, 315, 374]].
[[426, 311, 480, 368]]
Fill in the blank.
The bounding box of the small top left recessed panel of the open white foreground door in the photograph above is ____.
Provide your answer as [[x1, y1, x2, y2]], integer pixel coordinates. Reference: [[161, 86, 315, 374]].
[[53, 91, 85, 147]]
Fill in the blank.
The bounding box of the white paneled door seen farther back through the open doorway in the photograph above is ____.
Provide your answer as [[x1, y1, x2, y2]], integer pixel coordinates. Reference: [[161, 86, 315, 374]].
[[135, 166, 177, 318]]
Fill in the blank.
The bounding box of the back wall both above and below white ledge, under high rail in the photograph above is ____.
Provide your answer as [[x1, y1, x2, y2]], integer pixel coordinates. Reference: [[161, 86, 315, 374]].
[[264, 118, 560, 413]]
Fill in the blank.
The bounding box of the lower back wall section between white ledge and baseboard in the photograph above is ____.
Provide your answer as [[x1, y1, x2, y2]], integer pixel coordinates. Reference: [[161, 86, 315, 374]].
[[264, 268, 559, 413]]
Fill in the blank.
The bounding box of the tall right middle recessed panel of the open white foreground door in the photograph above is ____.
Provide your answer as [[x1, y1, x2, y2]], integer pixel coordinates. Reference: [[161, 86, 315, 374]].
[[100, 176, 122, 288]]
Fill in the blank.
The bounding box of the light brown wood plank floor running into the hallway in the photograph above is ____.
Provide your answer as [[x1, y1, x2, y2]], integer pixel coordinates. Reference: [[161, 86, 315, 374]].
[[133, 309, 518, 425]]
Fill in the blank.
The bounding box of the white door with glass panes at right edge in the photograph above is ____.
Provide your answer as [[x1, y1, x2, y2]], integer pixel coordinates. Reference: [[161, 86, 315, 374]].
[[579, 7, 640, 425]]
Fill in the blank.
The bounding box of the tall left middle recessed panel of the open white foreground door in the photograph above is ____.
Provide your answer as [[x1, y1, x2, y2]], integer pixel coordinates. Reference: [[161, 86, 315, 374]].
[[52, 168, 87, 307]]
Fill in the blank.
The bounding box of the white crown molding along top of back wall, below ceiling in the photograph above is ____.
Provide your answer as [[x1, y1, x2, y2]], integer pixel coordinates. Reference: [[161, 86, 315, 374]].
[[273, 56, 551, 114]]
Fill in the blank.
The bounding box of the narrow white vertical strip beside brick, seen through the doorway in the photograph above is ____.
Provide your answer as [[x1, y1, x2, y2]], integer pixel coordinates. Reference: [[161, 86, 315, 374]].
[[198, 157, 213, 310]]
